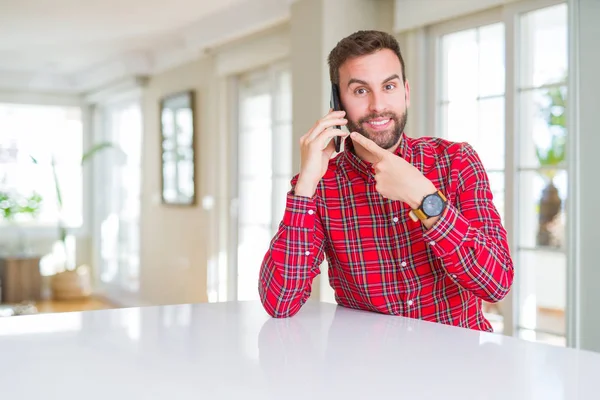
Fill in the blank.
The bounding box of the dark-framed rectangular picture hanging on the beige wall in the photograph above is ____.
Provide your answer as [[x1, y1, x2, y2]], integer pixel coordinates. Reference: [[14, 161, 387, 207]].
[[160, 91, 196, 206]]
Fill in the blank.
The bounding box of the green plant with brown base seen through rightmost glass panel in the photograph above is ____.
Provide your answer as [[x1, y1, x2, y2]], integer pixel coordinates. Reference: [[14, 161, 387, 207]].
[[536, 87, 566, 247]]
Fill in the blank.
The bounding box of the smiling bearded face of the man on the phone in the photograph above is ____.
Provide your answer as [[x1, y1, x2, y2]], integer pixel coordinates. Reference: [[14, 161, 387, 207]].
[[339, 49, 410, 149]]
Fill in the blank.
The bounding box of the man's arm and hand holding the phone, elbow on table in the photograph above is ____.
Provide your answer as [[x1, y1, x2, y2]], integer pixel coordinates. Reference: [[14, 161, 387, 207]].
[[258, 111, 348, 318]]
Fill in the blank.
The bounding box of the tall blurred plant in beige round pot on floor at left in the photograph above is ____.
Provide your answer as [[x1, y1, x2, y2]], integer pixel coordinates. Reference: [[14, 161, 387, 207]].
[[31, 142, 115, 300]]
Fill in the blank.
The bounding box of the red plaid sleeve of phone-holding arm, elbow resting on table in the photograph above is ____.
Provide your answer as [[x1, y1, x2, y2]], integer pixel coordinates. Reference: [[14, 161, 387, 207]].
[[258, 186, 325, 318]]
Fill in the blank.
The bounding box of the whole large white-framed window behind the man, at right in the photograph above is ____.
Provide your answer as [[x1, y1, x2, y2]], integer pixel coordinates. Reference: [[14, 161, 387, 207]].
[[430, 0, 568, 345]]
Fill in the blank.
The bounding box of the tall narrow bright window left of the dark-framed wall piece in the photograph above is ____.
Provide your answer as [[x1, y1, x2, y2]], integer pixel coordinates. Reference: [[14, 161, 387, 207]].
[[94, 101, 142, 292]]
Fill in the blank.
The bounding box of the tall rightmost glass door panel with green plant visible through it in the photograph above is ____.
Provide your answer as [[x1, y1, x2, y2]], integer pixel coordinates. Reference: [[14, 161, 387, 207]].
[[513, 4, 568, 345]]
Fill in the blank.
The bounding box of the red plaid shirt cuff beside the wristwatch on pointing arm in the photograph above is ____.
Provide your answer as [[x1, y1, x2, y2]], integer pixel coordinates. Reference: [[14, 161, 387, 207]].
[[423, 204, 470, 257]]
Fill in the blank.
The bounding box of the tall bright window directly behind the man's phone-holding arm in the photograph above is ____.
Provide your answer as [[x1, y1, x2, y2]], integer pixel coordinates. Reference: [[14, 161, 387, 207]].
[[236, 67, 292, 300]]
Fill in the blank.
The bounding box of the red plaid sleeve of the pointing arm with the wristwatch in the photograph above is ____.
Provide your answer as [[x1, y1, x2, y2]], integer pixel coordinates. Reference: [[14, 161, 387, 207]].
[[424, 144, 514, 302]]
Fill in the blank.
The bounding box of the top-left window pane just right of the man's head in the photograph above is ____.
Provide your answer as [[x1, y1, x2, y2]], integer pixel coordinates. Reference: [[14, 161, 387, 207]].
[[442, 29, 479, 101]]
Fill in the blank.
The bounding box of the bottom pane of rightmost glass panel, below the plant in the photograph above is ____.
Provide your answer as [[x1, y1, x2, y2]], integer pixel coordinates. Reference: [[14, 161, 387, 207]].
[[515, 250, 567, 335]]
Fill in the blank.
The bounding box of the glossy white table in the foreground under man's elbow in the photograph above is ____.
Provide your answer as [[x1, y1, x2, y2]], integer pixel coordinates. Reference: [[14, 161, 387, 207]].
[[0, 302, 600, 400]]
